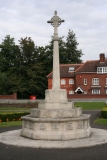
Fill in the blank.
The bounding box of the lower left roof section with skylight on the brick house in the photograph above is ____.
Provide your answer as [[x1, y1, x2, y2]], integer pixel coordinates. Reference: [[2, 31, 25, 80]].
[[47, 64, 82, 78]]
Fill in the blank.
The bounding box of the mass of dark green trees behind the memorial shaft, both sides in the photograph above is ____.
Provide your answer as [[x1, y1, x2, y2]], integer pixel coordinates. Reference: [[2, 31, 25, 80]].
[[0, 30, 83, 99]]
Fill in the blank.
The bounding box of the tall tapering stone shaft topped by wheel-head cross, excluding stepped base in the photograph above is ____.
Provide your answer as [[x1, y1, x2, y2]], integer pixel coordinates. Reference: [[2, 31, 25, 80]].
[[47, 11, 64, 90]]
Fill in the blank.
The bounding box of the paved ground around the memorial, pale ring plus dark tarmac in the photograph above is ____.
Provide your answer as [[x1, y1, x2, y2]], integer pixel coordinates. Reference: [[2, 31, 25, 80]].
[[0, 111, 107, 160]]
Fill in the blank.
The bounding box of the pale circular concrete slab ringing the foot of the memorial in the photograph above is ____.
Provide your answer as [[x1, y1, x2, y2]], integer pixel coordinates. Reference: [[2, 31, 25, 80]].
[[0, 128, 107, 148]]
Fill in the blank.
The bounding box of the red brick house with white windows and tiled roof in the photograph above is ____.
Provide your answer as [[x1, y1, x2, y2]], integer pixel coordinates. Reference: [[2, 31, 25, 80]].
[[47, 53, 107, 98]]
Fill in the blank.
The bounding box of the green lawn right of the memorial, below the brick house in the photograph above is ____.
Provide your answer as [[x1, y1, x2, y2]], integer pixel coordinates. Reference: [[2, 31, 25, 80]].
[[74, 102, 105, 110]]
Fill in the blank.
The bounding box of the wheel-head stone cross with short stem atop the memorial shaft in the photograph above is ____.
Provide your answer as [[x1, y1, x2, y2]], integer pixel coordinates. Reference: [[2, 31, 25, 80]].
[[47, 11, 64, 40]]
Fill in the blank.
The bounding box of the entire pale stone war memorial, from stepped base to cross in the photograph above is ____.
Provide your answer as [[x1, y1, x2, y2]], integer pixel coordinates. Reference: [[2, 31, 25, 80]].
[[21, 11, 91, 141]]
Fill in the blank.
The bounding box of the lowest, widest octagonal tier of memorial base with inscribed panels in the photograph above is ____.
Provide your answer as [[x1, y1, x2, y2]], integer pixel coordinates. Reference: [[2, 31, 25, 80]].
[[21, 115, 91, 140]]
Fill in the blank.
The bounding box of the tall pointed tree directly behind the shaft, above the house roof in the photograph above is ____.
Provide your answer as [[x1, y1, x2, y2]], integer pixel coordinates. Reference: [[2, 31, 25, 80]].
[[46, 30, 83, 64]]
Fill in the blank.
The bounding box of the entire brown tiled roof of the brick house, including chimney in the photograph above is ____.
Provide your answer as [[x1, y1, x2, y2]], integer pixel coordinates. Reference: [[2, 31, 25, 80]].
[[47, 54, 107, 78]]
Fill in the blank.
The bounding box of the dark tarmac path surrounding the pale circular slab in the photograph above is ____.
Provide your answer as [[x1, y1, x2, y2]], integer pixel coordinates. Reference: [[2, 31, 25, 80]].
[[0, 111, 107, 160]]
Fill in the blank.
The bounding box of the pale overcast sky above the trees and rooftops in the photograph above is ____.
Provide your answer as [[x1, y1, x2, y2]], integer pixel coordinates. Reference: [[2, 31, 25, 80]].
[[0, 0, 107, 61]]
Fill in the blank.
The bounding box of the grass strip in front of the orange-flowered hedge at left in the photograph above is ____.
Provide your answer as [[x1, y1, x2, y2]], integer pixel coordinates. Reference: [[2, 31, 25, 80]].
[[0, 121, 22, 128]]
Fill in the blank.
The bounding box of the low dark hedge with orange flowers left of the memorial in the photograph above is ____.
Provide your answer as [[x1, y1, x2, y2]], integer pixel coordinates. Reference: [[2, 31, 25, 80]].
[[0, 112, 29, 122]]
